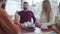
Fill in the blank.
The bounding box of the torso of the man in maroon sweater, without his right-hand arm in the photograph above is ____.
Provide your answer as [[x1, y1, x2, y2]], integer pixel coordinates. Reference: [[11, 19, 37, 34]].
[[18, 11, 32, 23]]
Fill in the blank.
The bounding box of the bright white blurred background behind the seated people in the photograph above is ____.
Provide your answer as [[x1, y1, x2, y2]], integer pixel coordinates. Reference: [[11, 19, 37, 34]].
[[6, 0, 60, 20]]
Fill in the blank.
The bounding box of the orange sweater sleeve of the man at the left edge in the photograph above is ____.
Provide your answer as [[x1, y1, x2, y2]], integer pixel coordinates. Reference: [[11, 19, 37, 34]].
[[0, 9, 19, 34]]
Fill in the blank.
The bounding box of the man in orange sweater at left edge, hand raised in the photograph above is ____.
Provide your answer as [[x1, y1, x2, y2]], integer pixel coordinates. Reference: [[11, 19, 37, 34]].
[[0, 0, 19, 34]]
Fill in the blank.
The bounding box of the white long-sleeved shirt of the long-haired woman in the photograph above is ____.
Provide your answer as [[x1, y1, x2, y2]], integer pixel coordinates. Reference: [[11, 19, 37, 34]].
[[40, 11, 55, 25]]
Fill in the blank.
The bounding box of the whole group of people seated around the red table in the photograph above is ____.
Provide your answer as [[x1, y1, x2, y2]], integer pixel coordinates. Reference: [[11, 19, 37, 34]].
[[0, 0, 60, 34]]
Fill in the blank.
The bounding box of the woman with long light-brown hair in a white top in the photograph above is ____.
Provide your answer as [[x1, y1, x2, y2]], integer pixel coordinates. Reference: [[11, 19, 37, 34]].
[[40, 0, 55, 26]]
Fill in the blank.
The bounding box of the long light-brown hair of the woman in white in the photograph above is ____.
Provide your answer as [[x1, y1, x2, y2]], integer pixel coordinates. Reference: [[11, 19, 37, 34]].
[[42, 0, 51, 22]]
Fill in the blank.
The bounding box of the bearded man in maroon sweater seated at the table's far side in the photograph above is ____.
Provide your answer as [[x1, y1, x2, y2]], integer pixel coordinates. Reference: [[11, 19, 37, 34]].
[[18, 2, 36, 27]]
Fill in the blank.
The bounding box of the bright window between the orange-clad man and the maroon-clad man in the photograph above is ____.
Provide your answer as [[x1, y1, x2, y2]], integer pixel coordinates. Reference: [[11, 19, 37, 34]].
[[6, 0, 21, 15]]
